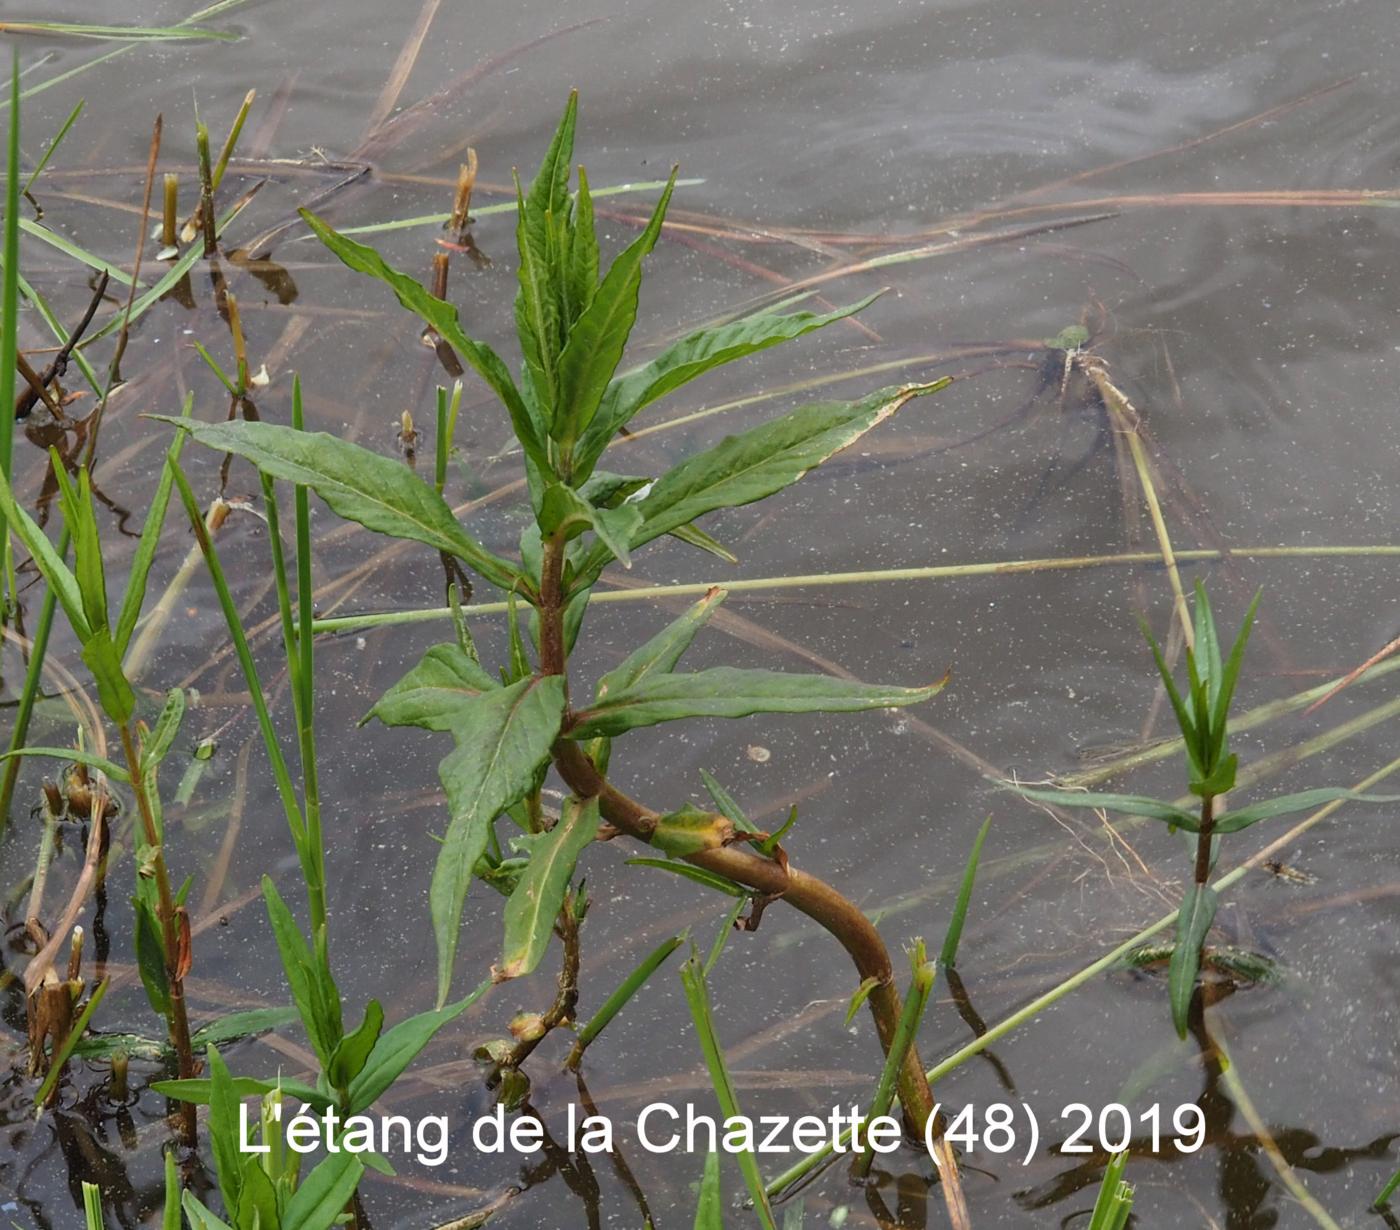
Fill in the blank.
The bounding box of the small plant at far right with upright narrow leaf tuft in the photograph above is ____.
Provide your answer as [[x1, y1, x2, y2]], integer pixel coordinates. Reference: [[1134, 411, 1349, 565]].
[[1022, 581, 1393, 1038]]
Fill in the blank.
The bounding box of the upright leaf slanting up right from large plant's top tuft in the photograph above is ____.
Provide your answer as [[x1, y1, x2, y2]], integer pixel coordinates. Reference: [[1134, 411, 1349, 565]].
[[550, 168, 676, 458]]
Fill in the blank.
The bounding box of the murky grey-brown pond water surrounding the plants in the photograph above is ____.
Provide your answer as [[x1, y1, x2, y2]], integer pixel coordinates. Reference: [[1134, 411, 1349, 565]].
[[0, 0, 1400, 1230]]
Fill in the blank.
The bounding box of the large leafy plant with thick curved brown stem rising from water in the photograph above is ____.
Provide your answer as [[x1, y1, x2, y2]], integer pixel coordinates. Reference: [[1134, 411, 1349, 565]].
[[153, 97, 955, 1203]]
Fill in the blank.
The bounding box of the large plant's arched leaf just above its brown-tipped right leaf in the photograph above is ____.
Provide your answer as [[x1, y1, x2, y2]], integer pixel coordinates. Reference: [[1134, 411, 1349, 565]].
[[574, 292, 879, 473]]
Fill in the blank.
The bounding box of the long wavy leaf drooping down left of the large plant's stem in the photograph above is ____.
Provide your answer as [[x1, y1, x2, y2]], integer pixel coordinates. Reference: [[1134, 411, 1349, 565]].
[[428, 674, 564, 1006]]
